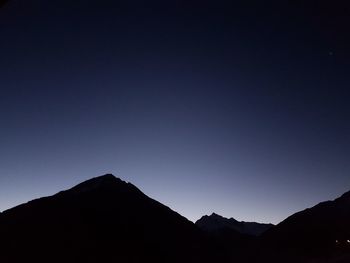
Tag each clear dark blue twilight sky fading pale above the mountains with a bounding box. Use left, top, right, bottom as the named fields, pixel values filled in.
left=0, top=0, right=350, bottom=223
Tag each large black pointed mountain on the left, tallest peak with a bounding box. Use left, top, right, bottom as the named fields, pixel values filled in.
left=0, top=175, right=222, bottom=263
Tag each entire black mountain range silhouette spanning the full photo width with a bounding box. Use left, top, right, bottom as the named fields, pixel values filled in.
left=0, top=174, right=350, bottom=263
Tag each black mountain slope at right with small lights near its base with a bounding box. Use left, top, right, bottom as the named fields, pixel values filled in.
left=262, top=192, right=350, bottom=262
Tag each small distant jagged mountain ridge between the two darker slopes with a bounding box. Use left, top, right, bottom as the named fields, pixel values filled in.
left=195, top=213, right=273, bottom=236
